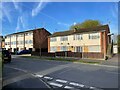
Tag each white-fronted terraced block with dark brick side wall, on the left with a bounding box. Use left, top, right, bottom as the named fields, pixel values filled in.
left=5, top=28, right=50, bottom=52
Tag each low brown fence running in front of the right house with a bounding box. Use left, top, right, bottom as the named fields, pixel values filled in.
left=32, top=51, right=104, bottom=59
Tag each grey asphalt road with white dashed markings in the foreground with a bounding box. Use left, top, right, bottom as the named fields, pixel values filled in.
left=3, top=57, right=120, bottom=90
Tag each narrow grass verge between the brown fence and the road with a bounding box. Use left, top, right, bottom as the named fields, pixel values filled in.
left=21, top=56, right=100, bottom=64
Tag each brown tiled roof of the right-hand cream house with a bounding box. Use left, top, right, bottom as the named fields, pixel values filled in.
left=49, top=25, right=110, bottom=37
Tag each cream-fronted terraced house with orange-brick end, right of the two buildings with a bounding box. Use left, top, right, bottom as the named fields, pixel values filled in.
left=48, top=25, right=111, bottom=58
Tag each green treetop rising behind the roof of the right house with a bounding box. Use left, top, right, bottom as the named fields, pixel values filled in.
left=70, top=20, right=101, bottom=29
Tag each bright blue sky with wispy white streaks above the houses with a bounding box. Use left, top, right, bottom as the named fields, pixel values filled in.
left=0, top=0, right=118, bottom=36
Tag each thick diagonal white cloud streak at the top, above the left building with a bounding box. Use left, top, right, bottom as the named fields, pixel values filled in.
left=32, top=0, right=47, bottom=17
